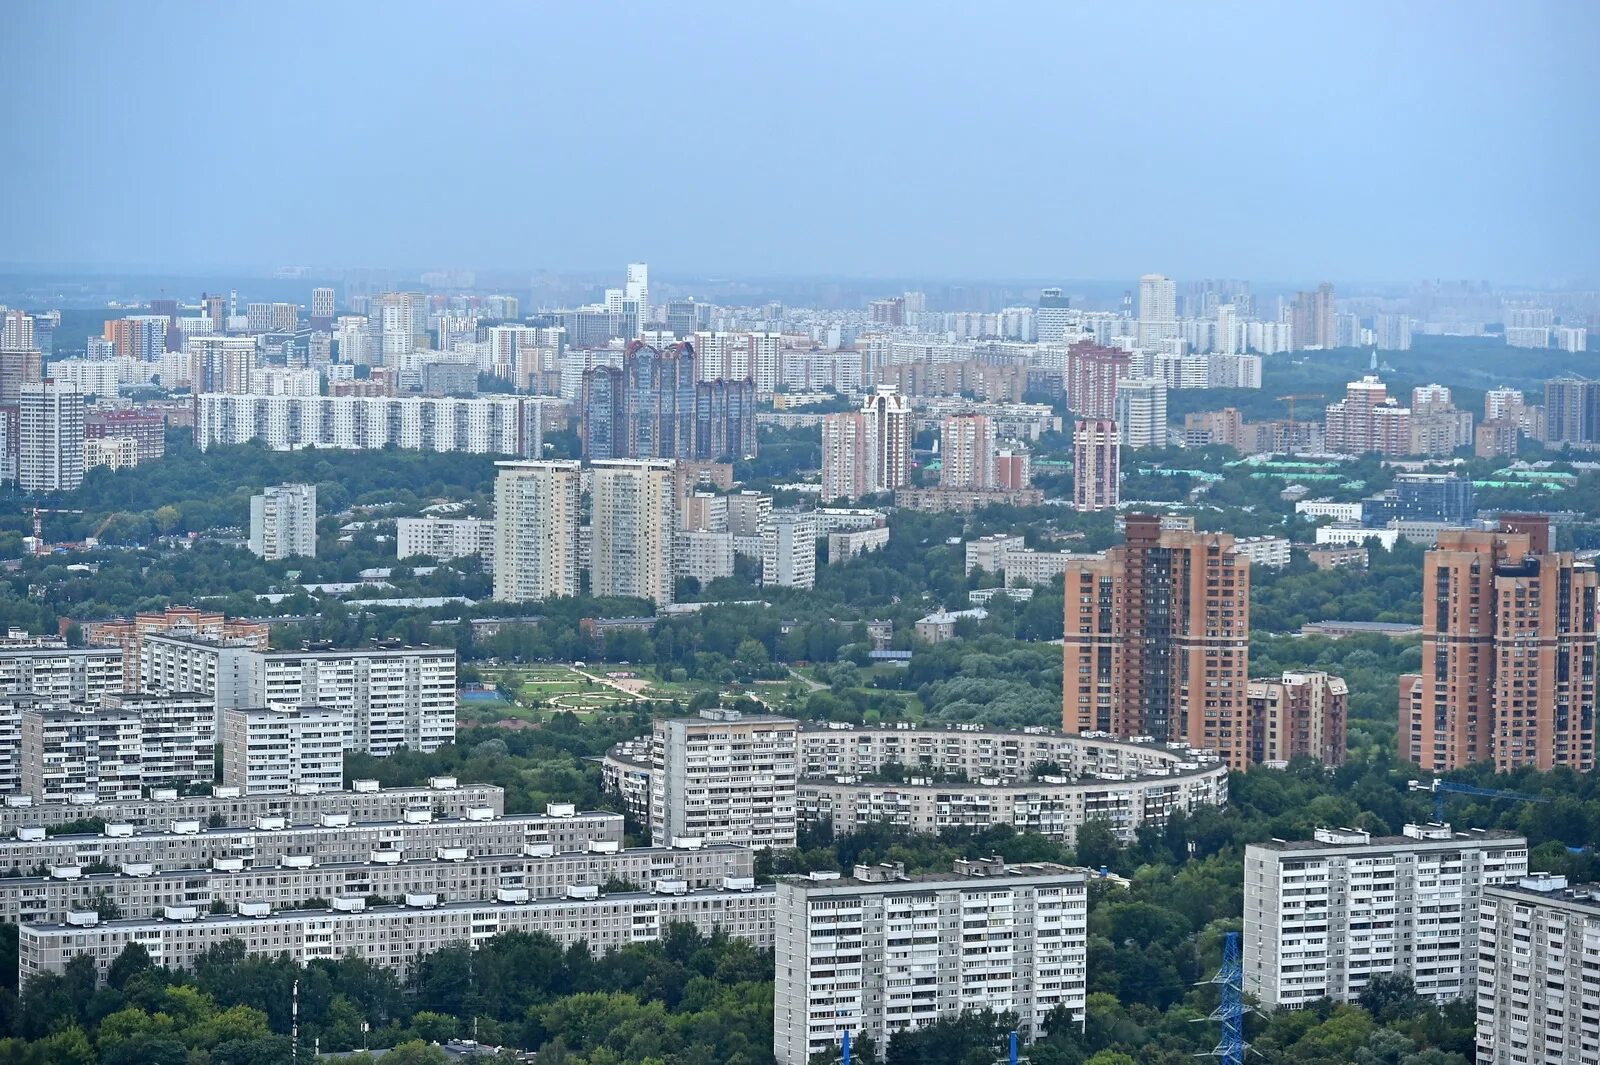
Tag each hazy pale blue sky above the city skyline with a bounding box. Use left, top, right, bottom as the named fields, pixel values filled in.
left=0, top=0, right=1600, bottom=283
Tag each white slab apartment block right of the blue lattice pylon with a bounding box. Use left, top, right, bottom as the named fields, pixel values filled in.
left=1243, top=825, right=1528, bottom=1009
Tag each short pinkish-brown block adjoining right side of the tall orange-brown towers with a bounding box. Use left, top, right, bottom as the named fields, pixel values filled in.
left=1245, top=670, right=1350, bottom=766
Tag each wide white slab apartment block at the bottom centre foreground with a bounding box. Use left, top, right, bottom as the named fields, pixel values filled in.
left=773, top=859, right=1088, bottom=1065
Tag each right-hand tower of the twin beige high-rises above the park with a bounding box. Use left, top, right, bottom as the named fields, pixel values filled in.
left=589, top=459, right=678, bottom=606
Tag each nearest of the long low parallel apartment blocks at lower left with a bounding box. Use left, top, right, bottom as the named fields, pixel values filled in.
left=19, top=884, right=776, bottom=982
